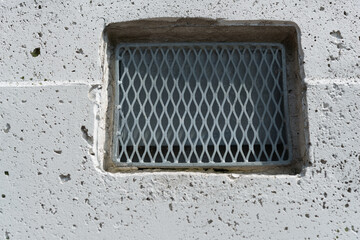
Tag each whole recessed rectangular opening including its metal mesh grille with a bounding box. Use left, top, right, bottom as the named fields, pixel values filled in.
left=102, top=18, right=308, bottom=174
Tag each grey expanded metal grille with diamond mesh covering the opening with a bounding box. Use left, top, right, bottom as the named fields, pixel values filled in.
left=114, top=43, right=291, bottom=167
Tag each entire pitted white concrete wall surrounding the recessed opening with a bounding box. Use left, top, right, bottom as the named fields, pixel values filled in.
left=0, top=0, right=360, bottom=239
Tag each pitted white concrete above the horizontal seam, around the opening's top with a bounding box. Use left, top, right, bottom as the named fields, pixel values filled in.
left=0, top=0, right=360, bottom=82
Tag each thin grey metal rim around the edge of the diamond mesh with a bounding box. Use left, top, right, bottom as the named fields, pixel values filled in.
left=111, top=42, right=293, bottom=168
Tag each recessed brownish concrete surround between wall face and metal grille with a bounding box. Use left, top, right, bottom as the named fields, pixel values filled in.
left=101, top=18, right=311, bottom=172
